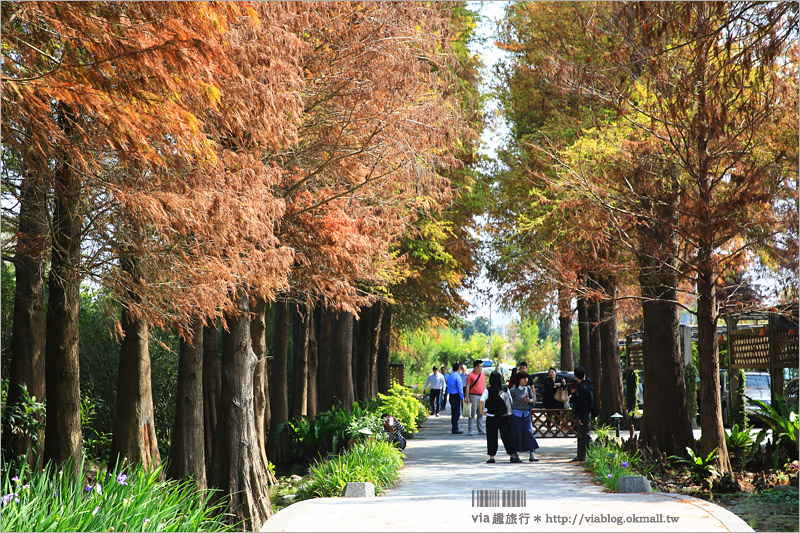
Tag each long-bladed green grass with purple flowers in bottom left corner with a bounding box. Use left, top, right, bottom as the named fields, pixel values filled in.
left=0, top=460, right=235, bottom=531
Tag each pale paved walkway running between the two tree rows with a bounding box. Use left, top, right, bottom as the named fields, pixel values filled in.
left=262, top=406, right=752, bottom=532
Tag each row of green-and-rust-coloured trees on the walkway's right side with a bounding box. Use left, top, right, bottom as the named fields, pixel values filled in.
left=489, top=2, right=798, bottom=472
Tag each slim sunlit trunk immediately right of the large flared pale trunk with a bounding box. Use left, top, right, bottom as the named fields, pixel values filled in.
left=250, top=298, right=270, bottom=472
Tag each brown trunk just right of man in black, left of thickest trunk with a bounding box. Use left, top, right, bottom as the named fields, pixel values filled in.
left=600, top=276, right=628, bottom=423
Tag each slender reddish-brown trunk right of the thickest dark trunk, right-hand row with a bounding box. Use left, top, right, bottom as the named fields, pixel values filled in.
left=692, top=258, right=731, bottom=474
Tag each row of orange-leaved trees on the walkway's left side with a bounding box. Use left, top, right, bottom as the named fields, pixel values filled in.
left=2, top=2, right=481, bottom=528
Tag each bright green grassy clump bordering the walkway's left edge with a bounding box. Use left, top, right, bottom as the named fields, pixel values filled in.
left=298, top=439, right=403, bottom=499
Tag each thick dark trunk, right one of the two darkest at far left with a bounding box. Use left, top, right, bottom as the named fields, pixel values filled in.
left=44, top=104, right=82, bottom=470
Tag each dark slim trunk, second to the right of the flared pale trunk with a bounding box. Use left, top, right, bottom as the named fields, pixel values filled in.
left=269, top=302, right=290, bottom=463
